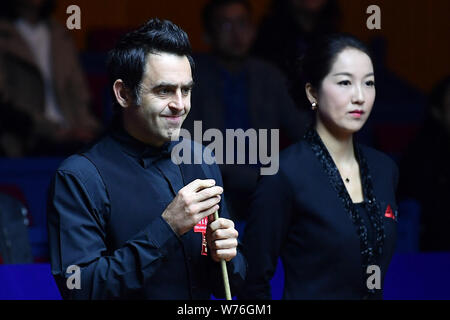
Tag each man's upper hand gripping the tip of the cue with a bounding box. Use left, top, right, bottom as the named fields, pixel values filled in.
left=162, top=179, right=223, bottom=236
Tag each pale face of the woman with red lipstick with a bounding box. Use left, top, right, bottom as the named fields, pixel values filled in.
left=316, top=48, right=375, bottom=134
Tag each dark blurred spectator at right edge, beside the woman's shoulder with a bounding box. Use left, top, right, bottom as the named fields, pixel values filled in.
left=399, top=77, right=450, bottom=251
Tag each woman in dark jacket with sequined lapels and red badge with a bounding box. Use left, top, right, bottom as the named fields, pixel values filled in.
left=241, top=34, right=398, bottom=299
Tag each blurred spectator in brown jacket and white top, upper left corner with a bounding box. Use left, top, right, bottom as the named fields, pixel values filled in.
left=0, top=0, right=99, bottom=156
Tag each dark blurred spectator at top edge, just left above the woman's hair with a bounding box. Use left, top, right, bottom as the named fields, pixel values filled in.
left=253, top=0, right=340, bottom=75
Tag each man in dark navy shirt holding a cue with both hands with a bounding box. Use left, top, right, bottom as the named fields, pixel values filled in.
left=48, top=19, right=246, bottom=299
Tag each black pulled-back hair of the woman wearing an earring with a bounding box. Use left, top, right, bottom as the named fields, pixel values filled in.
left=291, top=33, right=372, bottom=106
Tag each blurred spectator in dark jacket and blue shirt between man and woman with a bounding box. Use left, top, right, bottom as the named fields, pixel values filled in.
left=184, top=0, right=306, bottom=220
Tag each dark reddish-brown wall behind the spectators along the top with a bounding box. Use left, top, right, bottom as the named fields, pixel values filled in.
left=51, top=0, right=450, bottom=93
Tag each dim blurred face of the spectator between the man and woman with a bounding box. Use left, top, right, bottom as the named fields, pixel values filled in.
left=208, top=3, right=255, bottom=59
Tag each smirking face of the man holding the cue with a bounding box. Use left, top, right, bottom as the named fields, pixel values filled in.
left=125, top=53, right=193, bottom=146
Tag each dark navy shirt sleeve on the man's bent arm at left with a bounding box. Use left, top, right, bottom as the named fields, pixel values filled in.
left=47, top=156, right=178, bottom=299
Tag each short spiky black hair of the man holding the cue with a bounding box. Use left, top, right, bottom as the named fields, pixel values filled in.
left=107, top=18, right=194, bottom=110
